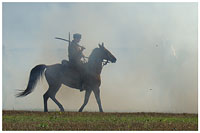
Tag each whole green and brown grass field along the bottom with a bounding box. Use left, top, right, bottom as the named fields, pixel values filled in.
left=2, top=111, right=198, bottom=131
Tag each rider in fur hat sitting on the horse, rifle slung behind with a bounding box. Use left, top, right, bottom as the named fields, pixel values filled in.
left=68, top=33, right=85, bottom=91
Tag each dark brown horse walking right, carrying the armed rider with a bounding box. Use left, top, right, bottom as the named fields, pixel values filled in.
left=16, top=43, right=117, bottom=112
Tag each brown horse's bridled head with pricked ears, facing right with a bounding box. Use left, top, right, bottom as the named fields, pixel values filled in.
left=99, top=43, right=117, bottom=63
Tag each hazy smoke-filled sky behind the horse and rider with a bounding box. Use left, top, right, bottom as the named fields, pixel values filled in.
left=2, top=2, right=198, bottom=113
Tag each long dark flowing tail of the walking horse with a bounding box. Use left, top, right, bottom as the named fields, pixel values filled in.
left=17, top=64, right=47, bottom=97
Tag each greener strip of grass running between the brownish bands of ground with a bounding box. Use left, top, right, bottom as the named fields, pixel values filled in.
left=3, top=114, right=198, bottom=124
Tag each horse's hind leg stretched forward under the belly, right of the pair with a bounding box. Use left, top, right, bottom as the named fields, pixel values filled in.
left=49, top=84, right=64, bottom=112
